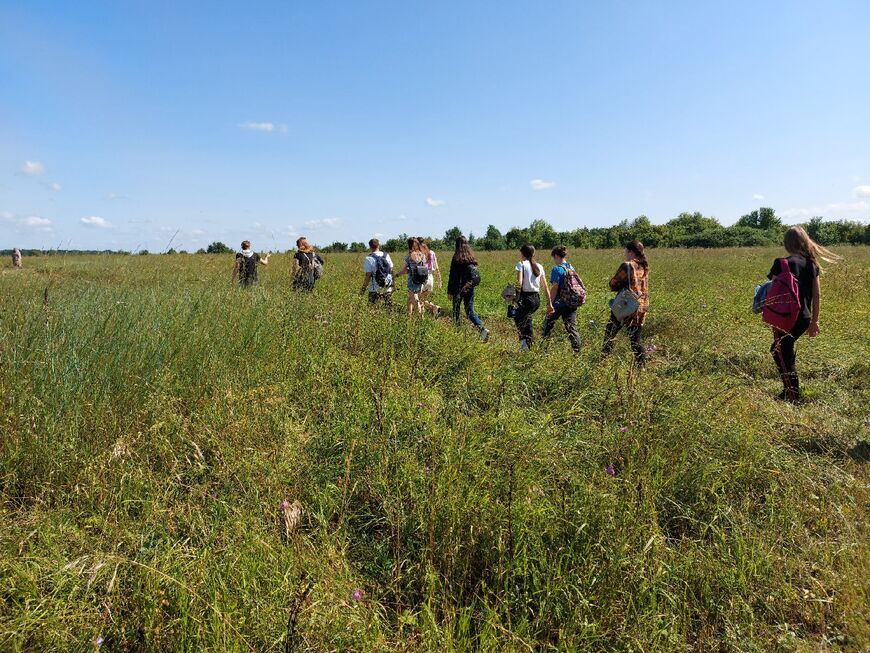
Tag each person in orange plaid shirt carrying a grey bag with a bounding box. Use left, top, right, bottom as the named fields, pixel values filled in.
left=602, top=240, right=649, bottom=365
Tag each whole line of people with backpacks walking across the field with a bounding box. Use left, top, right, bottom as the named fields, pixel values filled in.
left=233, top=226, right=839, bottom=402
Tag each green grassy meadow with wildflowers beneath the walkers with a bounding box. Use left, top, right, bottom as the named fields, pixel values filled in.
left=0, top=248, right=870, bottom=652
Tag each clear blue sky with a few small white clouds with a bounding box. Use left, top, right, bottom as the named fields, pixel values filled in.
left=0, top=0, right=870, bottom=251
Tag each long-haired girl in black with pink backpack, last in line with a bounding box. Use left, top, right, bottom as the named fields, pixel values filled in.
left=767, top=226, right=840, bottom=403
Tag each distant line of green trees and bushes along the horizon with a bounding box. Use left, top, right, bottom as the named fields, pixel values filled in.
left=322, top=208, right=870, bottom=253
